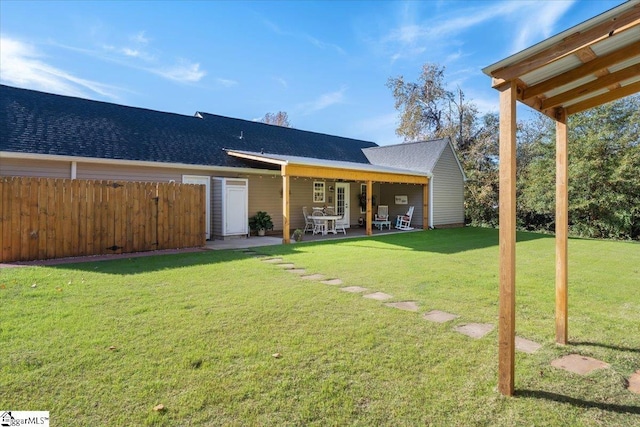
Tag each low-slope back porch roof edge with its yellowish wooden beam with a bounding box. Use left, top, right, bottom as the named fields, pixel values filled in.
left=227, top=150, right=430, bottom=185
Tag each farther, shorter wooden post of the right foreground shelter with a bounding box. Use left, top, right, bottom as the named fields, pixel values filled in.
left=556, top=109, right=569, bottom=344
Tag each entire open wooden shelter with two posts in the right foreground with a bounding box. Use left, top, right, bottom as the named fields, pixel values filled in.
left=483, top=0, right=640, bottom=396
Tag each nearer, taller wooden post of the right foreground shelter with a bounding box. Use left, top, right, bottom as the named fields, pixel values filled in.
left=498, top=81, right=517, bottom=396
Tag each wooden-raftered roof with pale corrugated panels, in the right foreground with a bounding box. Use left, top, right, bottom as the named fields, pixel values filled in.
left=483, top=0, right=640, bottom=119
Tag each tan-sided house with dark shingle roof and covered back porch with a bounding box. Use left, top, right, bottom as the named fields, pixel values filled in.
left=0, top=85, right=464, bottom=242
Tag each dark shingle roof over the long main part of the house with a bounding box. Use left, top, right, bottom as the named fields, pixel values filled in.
left=0, top=85, right=377, bottom=166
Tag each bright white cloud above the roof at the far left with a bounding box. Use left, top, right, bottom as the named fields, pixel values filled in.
left=0, top=35, right=118, bottom=100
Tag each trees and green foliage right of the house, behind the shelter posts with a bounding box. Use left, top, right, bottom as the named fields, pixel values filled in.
left=387, top=60, right=640, bottom=240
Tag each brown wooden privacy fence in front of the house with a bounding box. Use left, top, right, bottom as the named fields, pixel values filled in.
left=0, top=177, right=205, bottom=262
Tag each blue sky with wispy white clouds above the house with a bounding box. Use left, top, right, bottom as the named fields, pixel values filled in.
left=0, top=0, right=623, bottom=145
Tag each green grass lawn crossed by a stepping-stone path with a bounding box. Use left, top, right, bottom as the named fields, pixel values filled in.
left=0, top=228, right=640, bottom=426
